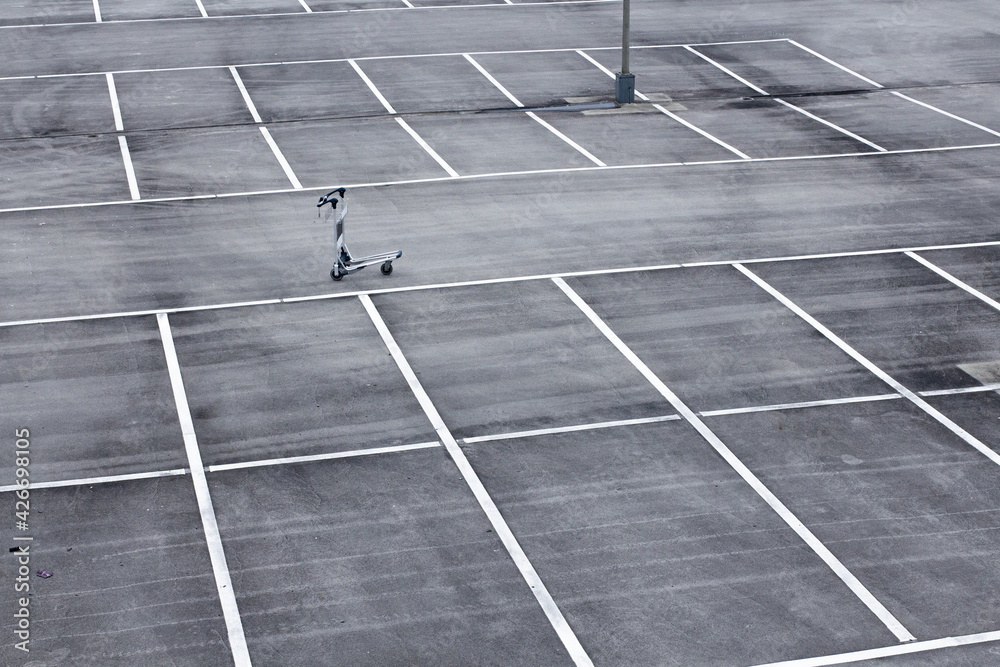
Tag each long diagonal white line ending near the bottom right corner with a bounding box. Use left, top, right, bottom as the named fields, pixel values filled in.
left=553, top=278, right=915, bottom=642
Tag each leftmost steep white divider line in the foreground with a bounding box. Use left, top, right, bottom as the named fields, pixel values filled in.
left=156, top=313, right=251, bottom=667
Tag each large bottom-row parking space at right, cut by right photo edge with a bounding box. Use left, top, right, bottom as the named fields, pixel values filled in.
left=709, top=401, right=1000, bottom=637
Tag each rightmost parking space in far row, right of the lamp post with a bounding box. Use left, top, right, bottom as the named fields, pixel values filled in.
left=696, top=40, right=876, bottom=95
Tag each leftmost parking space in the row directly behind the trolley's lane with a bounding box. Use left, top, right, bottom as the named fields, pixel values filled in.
left=0, top=136, right=129, bottom=208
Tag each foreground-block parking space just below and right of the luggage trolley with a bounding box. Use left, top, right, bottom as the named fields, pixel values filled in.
left=373, top=281, right=673, bottom=437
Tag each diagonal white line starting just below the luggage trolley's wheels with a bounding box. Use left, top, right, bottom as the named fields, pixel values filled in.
left=358, top=294, right=593, bottom=667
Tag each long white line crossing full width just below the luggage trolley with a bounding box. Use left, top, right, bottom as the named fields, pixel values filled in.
left=13, top=241, right=1000, bottom=328
